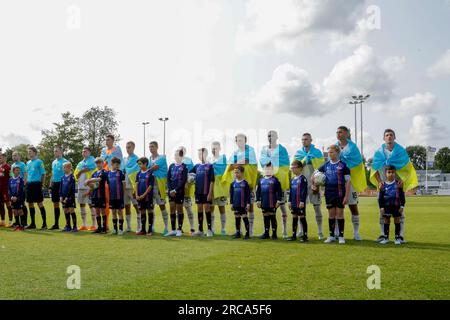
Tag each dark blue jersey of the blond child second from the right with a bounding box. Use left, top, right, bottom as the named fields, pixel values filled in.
left=319, top=160, right=350, bottom=198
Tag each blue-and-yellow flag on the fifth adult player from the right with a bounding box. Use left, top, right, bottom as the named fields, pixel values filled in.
left=225, top=145, right=258, bottom=190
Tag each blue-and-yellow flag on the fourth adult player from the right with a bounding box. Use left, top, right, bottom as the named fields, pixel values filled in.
left=259, top=144, right=290, bottom=190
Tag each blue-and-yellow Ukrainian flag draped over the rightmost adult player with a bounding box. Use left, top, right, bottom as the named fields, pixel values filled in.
left=370, top=143, right=419, bottom=191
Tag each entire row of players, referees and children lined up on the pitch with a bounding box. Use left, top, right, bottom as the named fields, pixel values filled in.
left=0, top=127, right=409, bottom=243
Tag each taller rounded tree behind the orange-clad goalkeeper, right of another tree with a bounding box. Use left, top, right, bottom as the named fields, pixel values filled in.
left=80, top=106, right=120, bottom=156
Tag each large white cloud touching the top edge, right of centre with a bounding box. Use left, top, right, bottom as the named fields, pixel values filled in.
left=236, top=0, right=365, bottom=52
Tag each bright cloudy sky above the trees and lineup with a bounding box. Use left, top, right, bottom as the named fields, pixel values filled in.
left=0, top=0, right=450, bottom=157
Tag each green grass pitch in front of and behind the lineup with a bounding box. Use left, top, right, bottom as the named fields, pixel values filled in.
left=0, top=197, right=450, bottom=299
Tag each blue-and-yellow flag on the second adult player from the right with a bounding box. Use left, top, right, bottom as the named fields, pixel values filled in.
left=336, top=139, right=367, bottom=192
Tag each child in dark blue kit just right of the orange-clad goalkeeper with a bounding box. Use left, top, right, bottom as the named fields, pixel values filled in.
left=107, top=157, right=126, bottom=236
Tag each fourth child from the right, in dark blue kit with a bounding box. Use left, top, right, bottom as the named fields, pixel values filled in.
left=256, top=162, right=283, bottom=240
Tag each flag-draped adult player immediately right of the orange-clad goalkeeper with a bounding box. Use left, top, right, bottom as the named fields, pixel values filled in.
left=122, top=141, right=140, bottom=232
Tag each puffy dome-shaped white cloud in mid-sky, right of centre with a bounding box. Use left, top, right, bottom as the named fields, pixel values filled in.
left=249, top=64, right=325, bottom=116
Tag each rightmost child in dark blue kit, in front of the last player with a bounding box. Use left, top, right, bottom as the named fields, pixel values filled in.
left=378, top=166, right=405, bottom=245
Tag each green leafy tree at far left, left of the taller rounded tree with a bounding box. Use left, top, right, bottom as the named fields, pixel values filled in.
left=37, top=112, right=83, bottom=185
